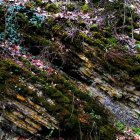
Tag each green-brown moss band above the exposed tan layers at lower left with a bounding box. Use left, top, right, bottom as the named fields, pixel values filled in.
left=0, top=55, right=118, bottom=138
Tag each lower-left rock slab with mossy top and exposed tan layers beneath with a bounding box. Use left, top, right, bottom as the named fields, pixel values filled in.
left=0, top=52, right=117, bottom=139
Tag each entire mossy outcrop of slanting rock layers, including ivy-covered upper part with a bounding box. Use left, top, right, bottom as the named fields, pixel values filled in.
left=0, top=1, right=140, bottom=140
